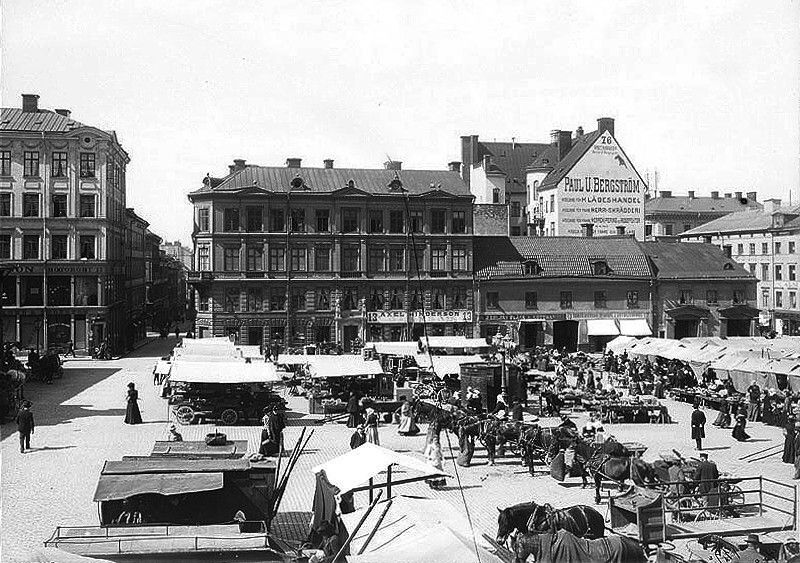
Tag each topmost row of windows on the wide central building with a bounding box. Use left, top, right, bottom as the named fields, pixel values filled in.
left=202, top=206, right=467, bottom=234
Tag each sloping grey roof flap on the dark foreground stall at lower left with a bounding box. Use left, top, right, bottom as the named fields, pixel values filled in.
left=94, top=473, right=223, bottom=502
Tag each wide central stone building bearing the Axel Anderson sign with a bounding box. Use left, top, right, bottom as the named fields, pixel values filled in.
left=189, top=158, right=473, bottom=349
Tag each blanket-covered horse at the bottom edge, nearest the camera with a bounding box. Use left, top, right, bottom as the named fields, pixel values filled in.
left=514, top=530, right=647, bottom=563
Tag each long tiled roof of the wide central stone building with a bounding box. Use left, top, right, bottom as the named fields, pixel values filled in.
left=192, top=165, right=472, bottom=197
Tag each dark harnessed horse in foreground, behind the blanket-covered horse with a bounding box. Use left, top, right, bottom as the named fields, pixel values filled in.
left=497, top=502, right=606, bottom=544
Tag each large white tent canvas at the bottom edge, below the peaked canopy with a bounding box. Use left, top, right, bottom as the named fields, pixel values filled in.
left=341, top=496, right=503, bottom=563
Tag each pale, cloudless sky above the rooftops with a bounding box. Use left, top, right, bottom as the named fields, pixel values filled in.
left=0, top=0, right=800, bottom=244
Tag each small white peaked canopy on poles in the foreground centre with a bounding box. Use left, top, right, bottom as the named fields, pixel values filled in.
left=311, top=442, right=444, bottom=493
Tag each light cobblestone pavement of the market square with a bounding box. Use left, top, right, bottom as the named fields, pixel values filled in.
left=0, top=339, right=794, bottom=561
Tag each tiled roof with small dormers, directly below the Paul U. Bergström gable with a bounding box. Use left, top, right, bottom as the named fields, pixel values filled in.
left=473, top=236, right=652, bottom=279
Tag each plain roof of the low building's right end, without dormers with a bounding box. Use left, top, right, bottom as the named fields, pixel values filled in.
left=639, top=242, right=755, bottom=279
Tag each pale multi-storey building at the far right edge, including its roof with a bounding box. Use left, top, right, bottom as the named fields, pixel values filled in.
left=680, top=199, right=800, bottom=335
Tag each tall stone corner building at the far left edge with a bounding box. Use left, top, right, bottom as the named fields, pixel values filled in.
left=0, top=94, right=130, bottom=352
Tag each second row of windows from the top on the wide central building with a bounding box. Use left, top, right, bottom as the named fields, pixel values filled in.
left=197, top=245, right=470, bottom=273
